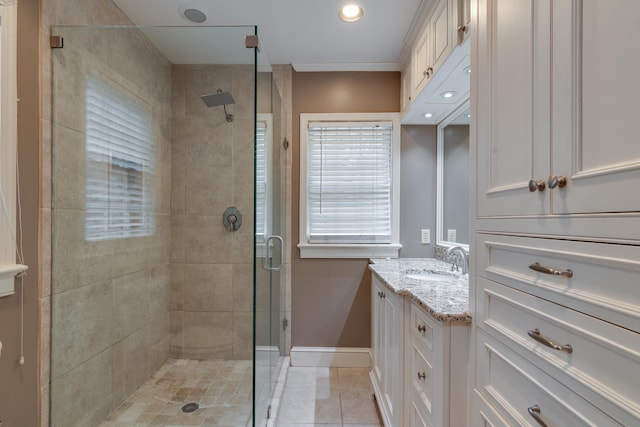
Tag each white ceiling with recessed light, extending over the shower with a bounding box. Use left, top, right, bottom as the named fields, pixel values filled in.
left=113, top=0, right=432, bottom=71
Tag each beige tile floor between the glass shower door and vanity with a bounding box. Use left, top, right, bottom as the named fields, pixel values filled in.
left=278, top=367, right=382, bottom=427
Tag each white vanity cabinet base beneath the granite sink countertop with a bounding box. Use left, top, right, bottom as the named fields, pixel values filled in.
left=370, top=274, right=469, bottom=427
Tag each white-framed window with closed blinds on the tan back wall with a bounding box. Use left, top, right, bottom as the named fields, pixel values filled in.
left=298, top=113, right=401, bottom=258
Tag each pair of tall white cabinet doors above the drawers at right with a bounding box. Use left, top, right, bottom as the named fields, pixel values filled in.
left=472, top=0, right=640, bottom=217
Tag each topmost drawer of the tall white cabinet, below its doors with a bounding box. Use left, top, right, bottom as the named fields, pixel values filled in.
left=476, top=233, right=640, bottom=331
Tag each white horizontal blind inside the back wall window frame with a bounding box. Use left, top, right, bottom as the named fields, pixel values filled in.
left=306, top=122, right=393, bottom=244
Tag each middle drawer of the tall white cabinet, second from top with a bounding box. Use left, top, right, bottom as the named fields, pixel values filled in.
left=476, top=278, right=640, bottom=425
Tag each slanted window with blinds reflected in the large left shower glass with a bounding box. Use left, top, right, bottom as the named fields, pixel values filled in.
left=85, top=78, right=155, bottom=241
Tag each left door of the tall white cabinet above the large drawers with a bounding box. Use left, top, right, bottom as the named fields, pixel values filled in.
left=471, top=0, right=551, bottom=217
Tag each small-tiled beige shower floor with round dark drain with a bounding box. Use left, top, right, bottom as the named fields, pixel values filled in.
left=100, top=359, right=252, bottom=427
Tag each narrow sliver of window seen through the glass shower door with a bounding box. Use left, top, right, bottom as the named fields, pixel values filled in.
left=256, top=114, right=272, bottom=243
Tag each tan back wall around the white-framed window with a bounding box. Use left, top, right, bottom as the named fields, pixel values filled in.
left=291, top=72, right=400, bottom=347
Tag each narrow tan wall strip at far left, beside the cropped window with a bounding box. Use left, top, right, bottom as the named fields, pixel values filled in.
left=0, top=0, right=40, bottom=427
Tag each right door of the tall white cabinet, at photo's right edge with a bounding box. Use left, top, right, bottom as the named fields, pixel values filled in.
left=550, top=0, right=640, bottom=213
